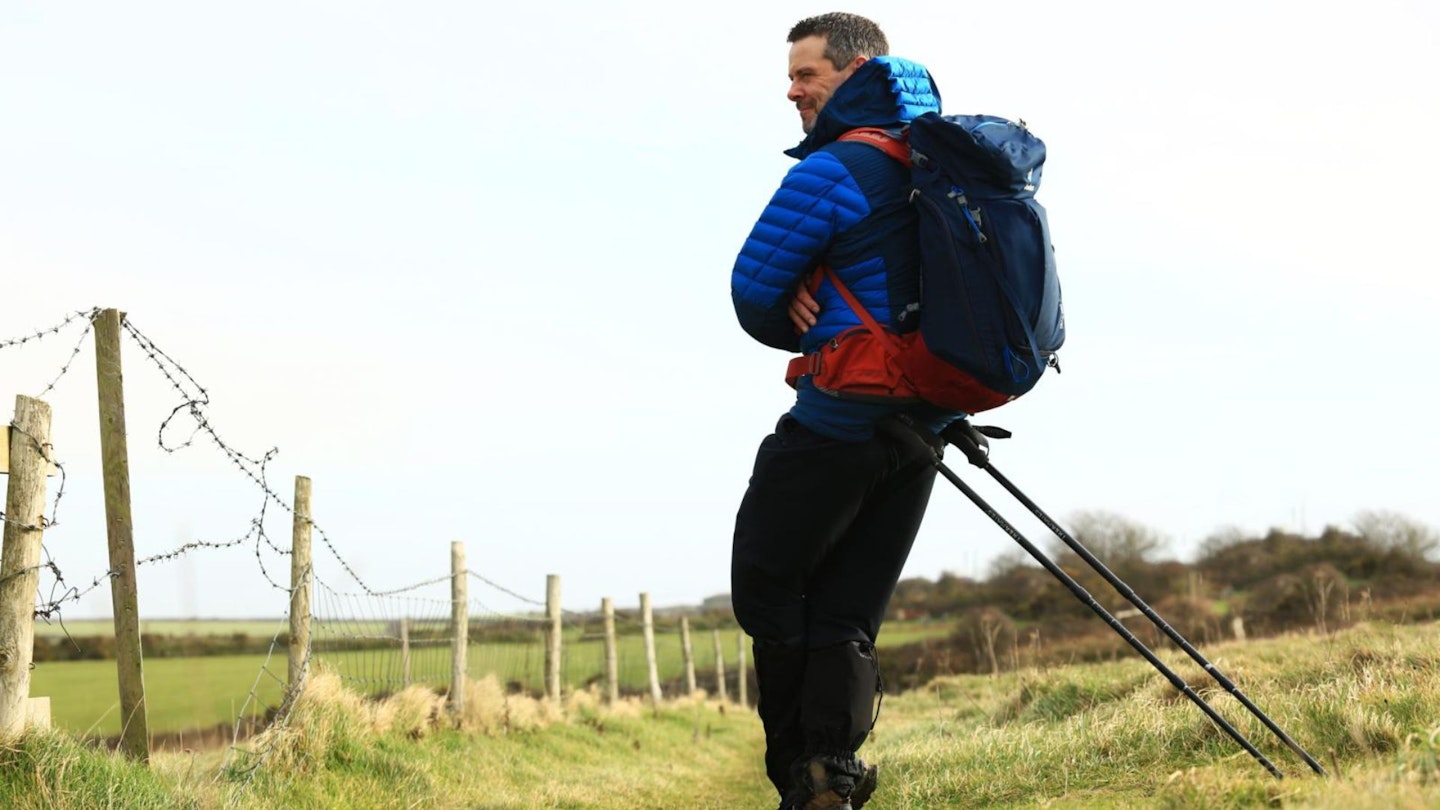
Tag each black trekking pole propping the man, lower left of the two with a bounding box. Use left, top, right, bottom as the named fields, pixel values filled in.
left=878, top=417, right=1284, bottom=778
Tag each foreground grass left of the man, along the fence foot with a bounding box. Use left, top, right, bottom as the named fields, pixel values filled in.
left=0, top=676, right=770, bottom=810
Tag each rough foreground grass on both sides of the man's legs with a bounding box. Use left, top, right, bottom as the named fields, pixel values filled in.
left=8, top=624, right=1440, bottom=810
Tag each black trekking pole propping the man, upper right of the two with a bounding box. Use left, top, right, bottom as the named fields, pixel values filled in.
left=940, top=422, right=1326, bottom=777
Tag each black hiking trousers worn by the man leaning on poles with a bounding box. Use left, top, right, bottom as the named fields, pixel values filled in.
left=730, top=415, right=935, bottom=794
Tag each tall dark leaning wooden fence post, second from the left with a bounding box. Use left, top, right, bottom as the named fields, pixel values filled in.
left=95, top=310, right=150, bottom=762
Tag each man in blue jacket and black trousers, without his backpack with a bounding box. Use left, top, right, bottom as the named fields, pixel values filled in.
left=732, top=13, right=958, bottom=810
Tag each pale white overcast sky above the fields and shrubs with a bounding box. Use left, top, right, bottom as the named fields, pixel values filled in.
left=0, top=0, right=1440, bottom=617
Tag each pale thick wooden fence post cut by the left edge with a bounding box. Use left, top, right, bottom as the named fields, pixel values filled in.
left=0, top=396, right=50, bottom=738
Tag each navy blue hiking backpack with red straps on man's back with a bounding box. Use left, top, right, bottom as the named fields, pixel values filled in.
left=834, top=112, right=1066, bottom=414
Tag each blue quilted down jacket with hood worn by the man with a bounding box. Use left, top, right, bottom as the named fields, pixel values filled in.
left=730, top=56, right=948, bottom=441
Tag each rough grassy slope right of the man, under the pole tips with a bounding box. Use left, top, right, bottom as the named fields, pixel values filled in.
left=867, top=624, right=1440, bottom=810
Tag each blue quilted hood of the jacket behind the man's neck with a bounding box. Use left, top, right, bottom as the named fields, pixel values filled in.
left=785, top=56, right=940, bottom=160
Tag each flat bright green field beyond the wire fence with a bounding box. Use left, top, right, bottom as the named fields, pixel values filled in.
left=30, top=621, right=949, bottom=736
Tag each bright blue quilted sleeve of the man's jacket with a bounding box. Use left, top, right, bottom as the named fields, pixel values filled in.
left=730, top=151, right=870, bottom=352
